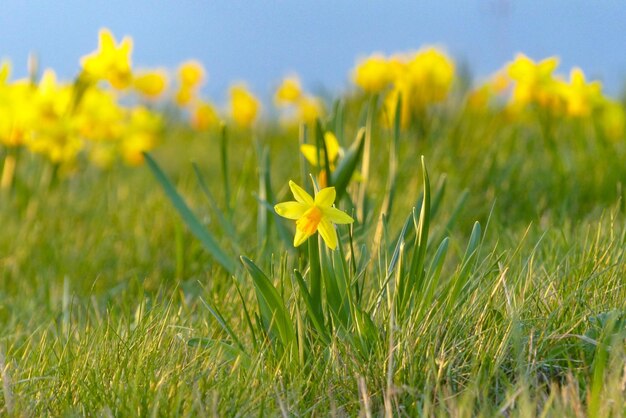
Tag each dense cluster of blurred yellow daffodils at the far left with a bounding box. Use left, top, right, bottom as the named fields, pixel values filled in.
left=0, top=30, right=166, bottom=171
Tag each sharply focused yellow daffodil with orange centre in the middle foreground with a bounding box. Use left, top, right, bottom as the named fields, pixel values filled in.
left=274, top=180, right=354, bottom=250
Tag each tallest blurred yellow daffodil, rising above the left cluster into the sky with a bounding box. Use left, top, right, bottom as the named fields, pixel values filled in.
left=81, top=29, right=133, bottom=90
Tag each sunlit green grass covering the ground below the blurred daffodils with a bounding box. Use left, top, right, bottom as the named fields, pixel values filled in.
left=0, top=99, right=626, bottom=416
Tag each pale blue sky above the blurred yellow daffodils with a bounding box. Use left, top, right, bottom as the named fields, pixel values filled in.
left=0, top=0, right=626, bottom=98
